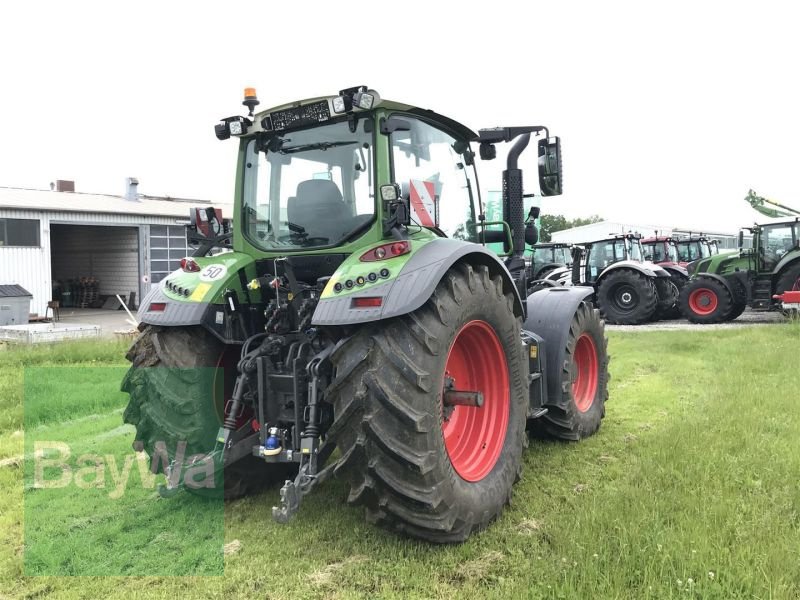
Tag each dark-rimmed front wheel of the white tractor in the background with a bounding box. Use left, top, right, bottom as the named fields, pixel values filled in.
left=597, top=269, right=658, bottom=325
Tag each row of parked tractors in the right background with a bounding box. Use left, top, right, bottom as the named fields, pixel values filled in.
left=531, top=218, right=800, bottom=325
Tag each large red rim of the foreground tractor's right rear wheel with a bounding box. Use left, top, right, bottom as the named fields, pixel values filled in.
left=442, top=321, right=510, bottom=482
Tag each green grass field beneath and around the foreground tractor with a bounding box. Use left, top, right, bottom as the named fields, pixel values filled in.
left=0, top=323, right=800, bottom=599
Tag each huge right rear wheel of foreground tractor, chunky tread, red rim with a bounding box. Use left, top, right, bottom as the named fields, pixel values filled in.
left=328, top=263, right=528, bottom=543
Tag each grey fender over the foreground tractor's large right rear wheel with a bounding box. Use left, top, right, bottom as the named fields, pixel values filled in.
left=312, top=238, right=523, bottom=325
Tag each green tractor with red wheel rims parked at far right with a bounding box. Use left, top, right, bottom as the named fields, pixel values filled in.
left=679, top=216, right=800, bottom=323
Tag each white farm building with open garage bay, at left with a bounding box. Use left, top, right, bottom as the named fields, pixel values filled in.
left=0, top=179, right=231, bottom=315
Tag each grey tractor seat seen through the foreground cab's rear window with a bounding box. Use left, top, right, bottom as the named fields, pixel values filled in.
left=286, top=179, right=354, bottom=246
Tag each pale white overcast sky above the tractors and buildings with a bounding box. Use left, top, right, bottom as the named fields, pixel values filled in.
left=0, top=0, right=800, bottom=231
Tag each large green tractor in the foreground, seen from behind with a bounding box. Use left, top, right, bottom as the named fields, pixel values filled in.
left=122, top=86, right=608, bottom=542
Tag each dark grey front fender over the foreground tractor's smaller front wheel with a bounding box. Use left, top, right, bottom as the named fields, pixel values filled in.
left=522, top=286, right=594, bottom=410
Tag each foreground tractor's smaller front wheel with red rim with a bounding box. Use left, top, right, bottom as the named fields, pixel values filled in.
left=531, top=302, right=609, bottom=440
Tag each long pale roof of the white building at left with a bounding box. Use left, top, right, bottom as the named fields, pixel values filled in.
left=0, top=187, right=233, bottom=218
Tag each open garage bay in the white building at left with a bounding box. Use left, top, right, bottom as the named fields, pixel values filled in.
left=50, top=224, right=139, bottom=298
